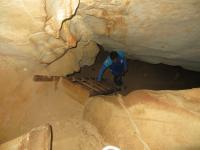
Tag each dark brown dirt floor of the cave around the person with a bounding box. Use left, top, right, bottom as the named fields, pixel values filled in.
left=74, top=50, right=200, bottom=95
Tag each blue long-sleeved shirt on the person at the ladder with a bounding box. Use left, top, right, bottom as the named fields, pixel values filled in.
left=97, top=51, right=127, bottom=81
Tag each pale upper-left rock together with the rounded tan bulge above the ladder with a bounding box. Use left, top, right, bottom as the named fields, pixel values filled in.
left=0, top=0, right=98, bottom=75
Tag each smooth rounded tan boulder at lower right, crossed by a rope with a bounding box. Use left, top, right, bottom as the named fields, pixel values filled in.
left=84, top=89, right=200, bottom=150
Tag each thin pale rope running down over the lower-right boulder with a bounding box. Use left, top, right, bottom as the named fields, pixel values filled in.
left=117, top=95, right=150, bottom=150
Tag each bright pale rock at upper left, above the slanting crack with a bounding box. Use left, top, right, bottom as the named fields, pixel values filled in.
left=0, top=0, right=79, bottom=64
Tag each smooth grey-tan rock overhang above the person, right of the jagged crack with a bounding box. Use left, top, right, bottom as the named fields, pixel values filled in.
left=72, top=0, right=200, bottom=70
